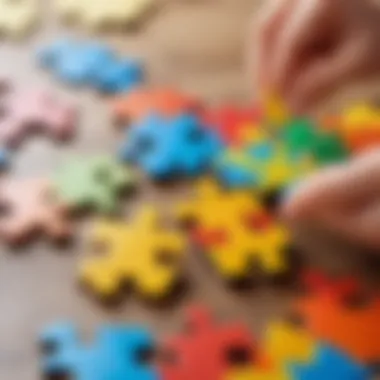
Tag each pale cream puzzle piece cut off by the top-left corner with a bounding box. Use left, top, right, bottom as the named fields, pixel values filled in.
left=0, top=0, right=40, bottom=37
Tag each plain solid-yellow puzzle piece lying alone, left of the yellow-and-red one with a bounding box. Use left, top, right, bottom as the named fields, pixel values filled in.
left=80, top=208, right=184, bottom=298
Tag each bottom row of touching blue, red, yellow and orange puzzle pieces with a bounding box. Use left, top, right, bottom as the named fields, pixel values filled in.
left=40, top=273, right=380, bottom=380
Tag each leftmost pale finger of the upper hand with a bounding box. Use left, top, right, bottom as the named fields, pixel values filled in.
left=252, top=0, right=297, bottom=88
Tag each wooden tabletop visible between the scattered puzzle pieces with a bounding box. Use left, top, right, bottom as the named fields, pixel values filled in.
left=0, top=0, right=378, bottom=380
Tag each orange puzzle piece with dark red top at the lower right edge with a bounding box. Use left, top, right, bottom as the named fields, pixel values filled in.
left=294, top=272, right=380, bottom=363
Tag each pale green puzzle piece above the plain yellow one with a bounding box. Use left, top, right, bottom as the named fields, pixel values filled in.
left=54, top=156, right=134, bottom=213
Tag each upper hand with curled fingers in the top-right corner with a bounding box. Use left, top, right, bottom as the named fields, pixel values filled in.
left=253, top=0, right=380, bottom=113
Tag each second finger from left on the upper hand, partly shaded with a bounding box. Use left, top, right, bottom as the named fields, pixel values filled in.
left=267, top=0, right=332, bottom=94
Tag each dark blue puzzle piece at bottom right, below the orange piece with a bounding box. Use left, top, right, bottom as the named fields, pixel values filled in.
left=289, top=345, right=371, bottom=380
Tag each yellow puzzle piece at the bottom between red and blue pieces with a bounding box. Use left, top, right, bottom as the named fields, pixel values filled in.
left=226, top=322, right=316, bottom=380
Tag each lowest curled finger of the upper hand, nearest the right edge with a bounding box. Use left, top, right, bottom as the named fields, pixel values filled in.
left=285, top=37, right=366, bottom=114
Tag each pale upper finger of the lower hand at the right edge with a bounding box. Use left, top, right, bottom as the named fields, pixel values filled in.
left=283, top=149, right=380, bottom=223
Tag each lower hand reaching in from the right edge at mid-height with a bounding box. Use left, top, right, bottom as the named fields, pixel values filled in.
left=283, top=149, right=380, bottom=248
